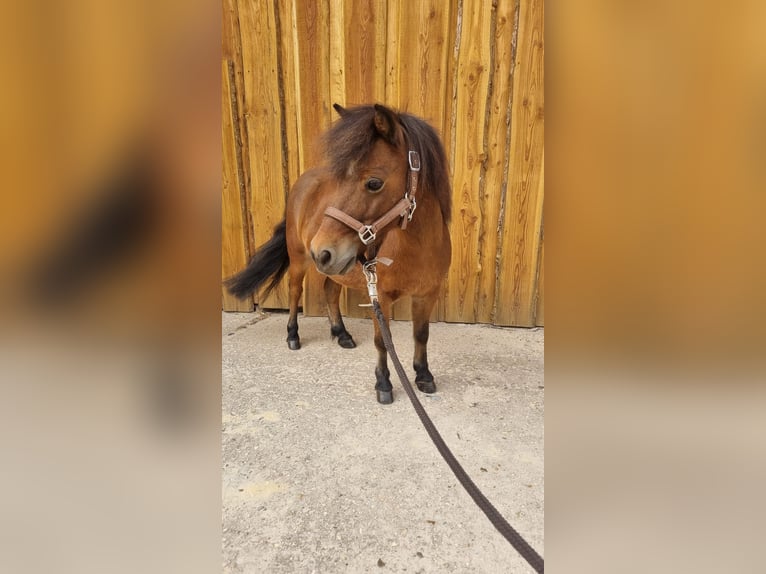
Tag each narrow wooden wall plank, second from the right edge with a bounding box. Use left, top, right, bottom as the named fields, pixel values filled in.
left=475, top=0, right=519, bottom=323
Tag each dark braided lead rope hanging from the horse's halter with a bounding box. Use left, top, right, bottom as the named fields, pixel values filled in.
left=371, top=304, right=545, bottom=573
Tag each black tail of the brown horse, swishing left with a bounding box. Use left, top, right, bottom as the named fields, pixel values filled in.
left=224, top=219, right=290, bottom=299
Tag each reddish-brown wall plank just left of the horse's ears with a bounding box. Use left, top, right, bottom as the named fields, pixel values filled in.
left=294, top=0, right=335, bottom=316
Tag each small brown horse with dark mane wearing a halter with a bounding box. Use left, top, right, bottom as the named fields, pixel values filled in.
left=226, top=104, right=452, bottom=404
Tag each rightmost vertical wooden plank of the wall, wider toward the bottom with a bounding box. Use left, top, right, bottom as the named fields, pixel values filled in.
left=495, top=0, right=544, bottom=326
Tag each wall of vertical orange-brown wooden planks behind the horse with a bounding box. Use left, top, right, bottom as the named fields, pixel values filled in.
left=222, top=0, right=544, bottom=327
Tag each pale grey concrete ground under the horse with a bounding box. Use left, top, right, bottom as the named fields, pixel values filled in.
left=222, top=313, right=544, bottom=574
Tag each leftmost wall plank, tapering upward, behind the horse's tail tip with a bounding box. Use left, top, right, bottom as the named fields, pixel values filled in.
left=221, top=59, right=253, bottom=311
